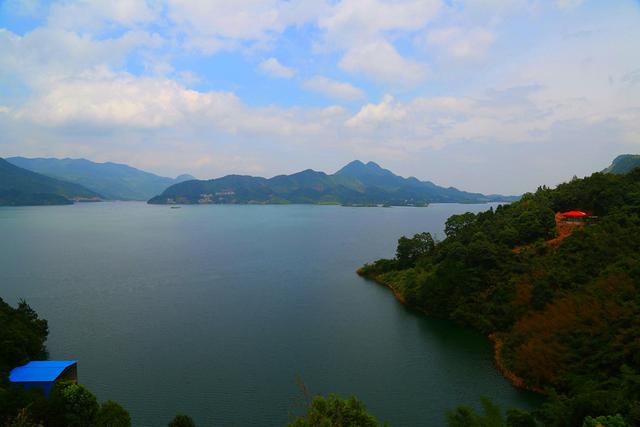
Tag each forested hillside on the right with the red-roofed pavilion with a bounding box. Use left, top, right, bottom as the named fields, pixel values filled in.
left=359, top=169, right=640, bottom=426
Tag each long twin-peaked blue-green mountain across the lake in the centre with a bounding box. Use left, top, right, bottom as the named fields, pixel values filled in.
left=149, top=160, right=517, bottom=206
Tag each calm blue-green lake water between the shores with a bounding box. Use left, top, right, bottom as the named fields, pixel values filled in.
left=0, top=203, right=537, bottom=427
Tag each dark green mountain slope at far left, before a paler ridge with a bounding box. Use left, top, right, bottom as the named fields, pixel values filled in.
left=0, top=158, right=101, bottom=206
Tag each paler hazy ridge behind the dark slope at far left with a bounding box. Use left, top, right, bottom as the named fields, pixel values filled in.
left=7, top=157, right=195, bottom=200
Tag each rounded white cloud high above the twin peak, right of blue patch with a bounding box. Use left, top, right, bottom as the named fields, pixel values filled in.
left=338, top=40, right=427, bottom=86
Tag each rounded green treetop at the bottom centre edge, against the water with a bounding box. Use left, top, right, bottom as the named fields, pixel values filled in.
left=289, top=394, right=380, bottom=427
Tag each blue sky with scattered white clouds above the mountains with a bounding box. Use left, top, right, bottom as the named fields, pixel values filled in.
left=0, top=0, right=640, bottom=194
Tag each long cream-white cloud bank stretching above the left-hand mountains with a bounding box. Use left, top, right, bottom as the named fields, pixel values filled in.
left=14, top=69, right=344, bottom=137
